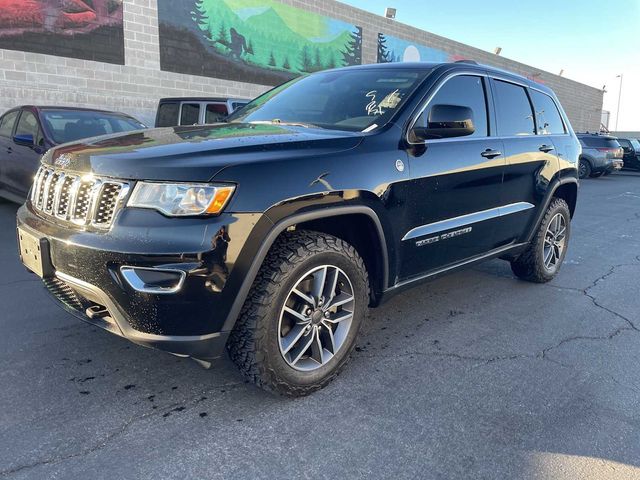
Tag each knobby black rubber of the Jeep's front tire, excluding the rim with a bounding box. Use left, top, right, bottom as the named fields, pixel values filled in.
left=227, top=230, right=369, bottom=397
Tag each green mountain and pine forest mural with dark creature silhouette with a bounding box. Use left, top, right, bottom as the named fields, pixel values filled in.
left=158, top=0, right=362, bottom=85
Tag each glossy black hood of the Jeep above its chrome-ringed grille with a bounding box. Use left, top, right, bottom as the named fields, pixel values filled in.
left=42, top=123, right=363, bottom=182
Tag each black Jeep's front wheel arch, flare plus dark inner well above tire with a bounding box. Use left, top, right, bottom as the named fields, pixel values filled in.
left=222, top=206, right=389, bottom=332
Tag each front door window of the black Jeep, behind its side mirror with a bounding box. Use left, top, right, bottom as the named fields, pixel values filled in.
left=416, top=75, right=489, bottom=137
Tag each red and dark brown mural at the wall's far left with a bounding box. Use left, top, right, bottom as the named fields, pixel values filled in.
left=0, top=0, right=124, bottom=64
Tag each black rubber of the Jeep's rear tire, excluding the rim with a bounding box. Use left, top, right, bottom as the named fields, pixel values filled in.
left=511, top=198, right=571, bottom=283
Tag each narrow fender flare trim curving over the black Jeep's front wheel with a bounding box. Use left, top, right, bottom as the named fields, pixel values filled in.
left=222, top=206, right=389, bottom=332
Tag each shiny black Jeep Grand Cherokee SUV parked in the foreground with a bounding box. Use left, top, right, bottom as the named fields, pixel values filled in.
left=17, top=62, right=580, bottom=395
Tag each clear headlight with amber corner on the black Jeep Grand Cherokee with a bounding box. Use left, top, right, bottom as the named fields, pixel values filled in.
left=127, top=182, right=235, bottom=216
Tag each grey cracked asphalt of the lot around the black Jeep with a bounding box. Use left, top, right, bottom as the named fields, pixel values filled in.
left=0, top=172, right=640, bottom=480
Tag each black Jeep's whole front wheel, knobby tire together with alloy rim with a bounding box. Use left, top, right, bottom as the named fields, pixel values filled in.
left=227, top=230, right=369, bottom=397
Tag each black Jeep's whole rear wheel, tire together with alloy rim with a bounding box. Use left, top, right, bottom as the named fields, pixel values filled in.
left=511, top=198, right=571, bottom=283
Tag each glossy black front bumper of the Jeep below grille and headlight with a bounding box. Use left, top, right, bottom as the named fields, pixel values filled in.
left=17, top=204, right=270, bottom=360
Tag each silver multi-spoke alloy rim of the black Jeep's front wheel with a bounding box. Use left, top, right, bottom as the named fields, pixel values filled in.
left=278, top=265, right=355, bottom=371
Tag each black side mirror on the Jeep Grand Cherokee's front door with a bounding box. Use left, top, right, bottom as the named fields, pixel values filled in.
left=412, top=105, right=476, bottom=140
